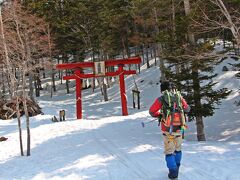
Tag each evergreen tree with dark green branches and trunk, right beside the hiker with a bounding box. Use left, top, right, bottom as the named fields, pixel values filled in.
left=166, top=0, right=230, bottom=141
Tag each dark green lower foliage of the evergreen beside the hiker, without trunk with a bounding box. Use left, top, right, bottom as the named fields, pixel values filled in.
left=168, top=47, right=231, bottom=120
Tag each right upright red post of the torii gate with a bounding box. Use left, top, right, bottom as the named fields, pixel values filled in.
left=118, top=65, right=128, bottom=116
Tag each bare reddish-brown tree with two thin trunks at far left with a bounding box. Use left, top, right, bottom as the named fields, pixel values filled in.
left=0, top=1, right=49, bottom=156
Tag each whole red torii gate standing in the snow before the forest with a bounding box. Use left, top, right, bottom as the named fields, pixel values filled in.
left=56, top=57, right=141, bottom=119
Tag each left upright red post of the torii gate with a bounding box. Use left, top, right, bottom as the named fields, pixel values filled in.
left=75, top=70, right=82, bottom=119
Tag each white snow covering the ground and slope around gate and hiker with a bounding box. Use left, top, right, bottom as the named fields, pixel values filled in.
left=0, top=56, right=240, bottom=180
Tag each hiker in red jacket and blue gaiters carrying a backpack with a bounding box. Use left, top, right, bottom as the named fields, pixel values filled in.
left=149, top=81, right=190, bottom=179
